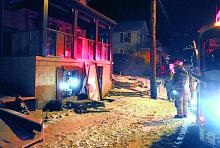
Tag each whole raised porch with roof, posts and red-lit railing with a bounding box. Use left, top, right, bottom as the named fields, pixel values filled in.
left=0, top=0, right=116, bottom=61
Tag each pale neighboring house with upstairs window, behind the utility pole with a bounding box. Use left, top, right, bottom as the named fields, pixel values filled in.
left=113, top=20, right=150, bottom=54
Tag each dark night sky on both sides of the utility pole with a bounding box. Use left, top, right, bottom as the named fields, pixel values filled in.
left=88, top=0, right=219, bottom=51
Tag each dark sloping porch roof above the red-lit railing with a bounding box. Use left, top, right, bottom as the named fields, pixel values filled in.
left=11, top=0, right=117, bottom=26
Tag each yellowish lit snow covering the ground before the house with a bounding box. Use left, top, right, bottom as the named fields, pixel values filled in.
left=37, top=76, right=184, bottom=148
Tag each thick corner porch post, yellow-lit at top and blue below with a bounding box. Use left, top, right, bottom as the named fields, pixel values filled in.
left=39, top=0, right=49, bottom=56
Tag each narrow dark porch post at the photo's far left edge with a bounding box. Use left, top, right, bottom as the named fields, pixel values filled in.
left=0, top=0, right=4, bottom=56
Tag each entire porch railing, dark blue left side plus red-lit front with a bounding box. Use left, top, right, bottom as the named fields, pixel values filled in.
left=12, top=29, right=110, bottom=61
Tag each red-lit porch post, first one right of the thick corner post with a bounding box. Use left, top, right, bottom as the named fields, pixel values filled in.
left=71, top=9, right=78, bottom=59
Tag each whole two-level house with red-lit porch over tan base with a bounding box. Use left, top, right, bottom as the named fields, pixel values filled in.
left=0, top=0, right=116, bottom=107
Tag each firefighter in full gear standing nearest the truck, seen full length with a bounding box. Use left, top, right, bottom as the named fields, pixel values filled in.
left=172, top=61, right=190, bottom=118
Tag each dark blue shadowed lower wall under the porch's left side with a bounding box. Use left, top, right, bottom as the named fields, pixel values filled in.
left=0, top=57, right=35, bottom=96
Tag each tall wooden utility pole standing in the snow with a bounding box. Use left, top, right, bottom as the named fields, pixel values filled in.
left=150, top=0, right=157, bottom=99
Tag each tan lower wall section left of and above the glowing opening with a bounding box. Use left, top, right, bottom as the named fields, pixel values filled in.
left=35, top=57, right=83, bottom=108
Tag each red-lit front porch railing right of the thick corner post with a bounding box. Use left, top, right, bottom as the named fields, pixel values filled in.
left=47, top=29, right=110, bottom=61
